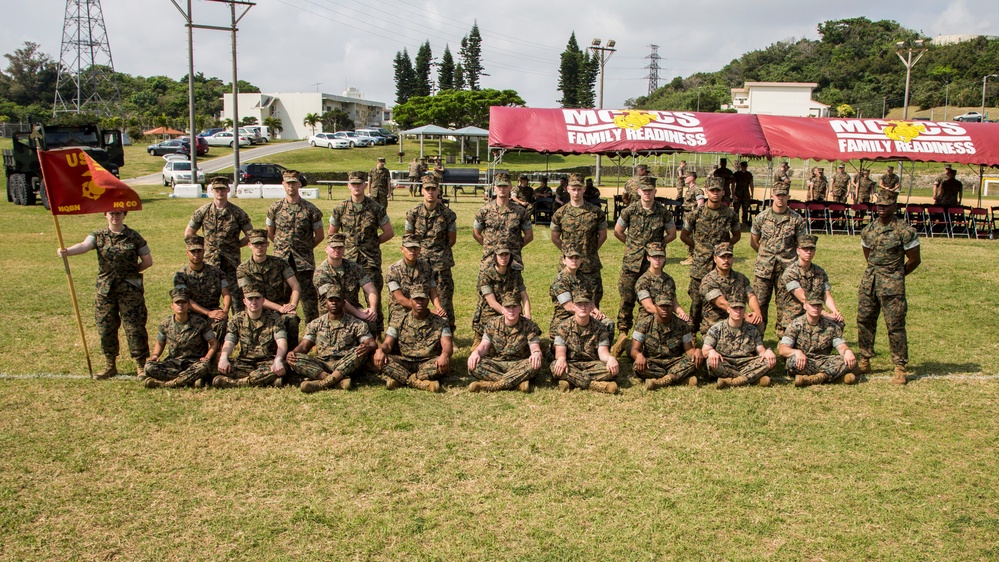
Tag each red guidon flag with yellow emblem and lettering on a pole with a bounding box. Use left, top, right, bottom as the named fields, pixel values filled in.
left=38, top=148, right=142, bottom=215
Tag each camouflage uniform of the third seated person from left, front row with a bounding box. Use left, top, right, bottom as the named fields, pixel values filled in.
left=288, top=308, right=371, bottom=380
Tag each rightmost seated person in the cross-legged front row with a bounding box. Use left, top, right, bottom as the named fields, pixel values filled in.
left=777, top=297, right=857, bottom=387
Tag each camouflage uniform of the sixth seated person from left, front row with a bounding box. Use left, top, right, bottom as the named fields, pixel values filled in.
left=552, top=312, right=615, bottom=388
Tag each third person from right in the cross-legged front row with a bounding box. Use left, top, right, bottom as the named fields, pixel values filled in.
left=631, top=293, right=704, bottom=390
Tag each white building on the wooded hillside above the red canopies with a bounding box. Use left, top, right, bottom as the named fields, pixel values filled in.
left=722, top=82, right=829, bottom=117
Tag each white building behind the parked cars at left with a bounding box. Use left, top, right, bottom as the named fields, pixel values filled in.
left=221, top=88, right=386, bottom=139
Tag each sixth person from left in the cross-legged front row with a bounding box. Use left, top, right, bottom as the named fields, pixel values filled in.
left=551, top=291, right=619, bottom=394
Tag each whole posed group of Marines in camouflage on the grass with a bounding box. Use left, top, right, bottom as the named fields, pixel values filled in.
left=60, top=152, right=919, bottom=393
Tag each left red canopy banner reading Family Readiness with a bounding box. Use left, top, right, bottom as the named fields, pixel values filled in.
left=489, top=107, right=770, bottom=157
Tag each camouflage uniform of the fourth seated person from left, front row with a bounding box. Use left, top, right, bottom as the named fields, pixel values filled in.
left=381, top=313, right=451, bottom=384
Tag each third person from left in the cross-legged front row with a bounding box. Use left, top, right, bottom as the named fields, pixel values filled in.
left=288, top=283, right=377, bottom=393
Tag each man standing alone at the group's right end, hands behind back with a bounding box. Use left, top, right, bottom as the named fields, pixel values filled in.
left=857, top=189, right=921, bottom=384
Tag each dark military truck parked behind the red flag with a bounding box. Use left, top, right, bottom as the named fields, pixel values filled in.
left=3, top=125, right=125, bottom=209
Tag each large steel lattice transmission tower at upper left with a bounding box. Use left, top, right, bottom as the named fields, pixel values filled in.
left=52, top=0, right=121, bottom=117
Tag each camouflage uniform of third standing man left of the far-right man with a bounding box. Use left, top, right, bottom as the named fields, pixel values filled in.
left=617, top=200, right=676, bottom=334
